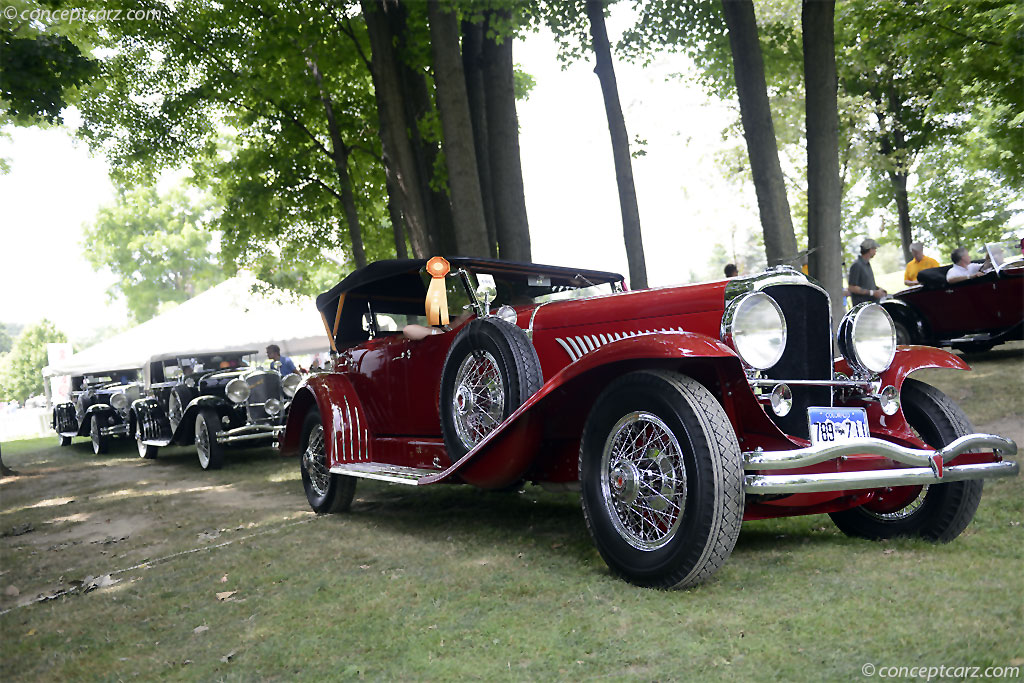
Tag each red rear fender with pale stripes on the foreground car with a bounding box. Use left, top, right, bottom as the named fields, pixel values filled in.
left=281, top=373, right=373, bottom=467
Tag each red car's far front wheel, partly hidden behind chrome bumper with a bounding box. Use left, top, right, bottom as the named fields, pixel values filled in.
left=829, top=379, right=983, bottom=543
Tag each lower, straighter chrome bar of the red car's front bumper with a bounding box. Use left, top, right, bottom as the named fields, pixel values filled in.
left=743, top=460, right=1020, bottom=495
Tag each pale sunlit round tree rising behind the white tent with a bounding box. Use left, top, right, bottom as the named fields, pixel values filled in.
left=83, top=187, right=224, bottom=323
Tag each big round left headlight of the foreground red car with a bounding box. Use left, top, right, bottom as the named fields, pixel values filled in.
left=722, top=292, right=786, bottom=370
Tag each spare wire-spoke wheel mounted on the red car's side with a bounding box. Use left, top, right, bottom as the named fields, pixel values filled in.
left=438, top=317, right=544, bottom=462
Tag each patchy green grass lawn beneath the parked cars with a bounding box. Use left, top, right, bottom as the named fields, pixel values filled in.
left=0, top=343, right=1024, bottom=681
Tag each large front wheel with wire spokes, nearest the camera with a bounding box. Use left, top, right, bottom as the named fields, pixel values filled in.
left=580, top=371, right=744, bottom=589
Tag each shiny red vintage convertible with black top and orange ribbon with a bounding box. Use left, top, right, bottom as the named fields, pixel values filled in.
left=282, top=258, right=1019, bottom=588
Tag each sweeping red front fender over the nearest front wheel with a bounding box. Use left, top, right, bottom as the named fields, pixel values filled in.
left=421, top=332, right=742, bottom=488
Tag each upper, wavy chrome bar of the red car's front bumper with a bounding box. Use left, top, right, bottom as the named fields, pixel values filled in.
left=743, top=434, right=1017, bottom=470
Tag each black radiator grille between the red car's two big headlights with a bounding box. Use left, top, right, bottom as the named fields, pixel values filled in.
left=762, top=284, right=833, bottom=438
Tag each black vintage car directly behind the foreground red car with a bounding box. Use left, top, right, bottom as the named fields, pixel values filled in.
left=130, top=350, right=301, bottom=469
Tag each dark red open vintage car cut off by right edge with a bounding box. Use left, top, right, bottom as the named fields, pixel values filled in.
left=882, top=241, right=1024, bottom=352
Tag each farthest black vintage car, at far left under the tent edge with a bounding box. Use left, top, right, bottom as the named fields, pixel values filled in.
left=51, top=369, right=142, bottom=455
